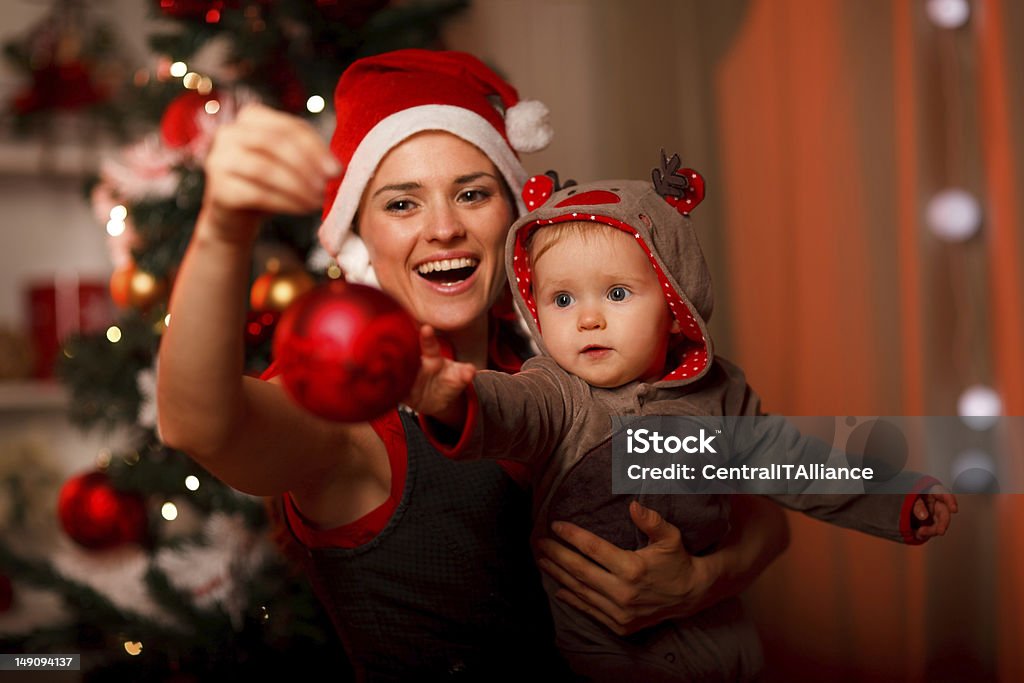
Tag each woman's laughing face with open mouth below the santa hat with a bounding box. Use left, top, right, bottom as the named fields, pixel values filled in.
left=357, top=131, right=513, bottom=332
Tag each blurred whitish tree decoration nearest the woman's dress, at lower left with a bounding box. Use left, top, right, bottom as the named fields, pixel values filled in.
left=155, top=513, right=274, bottom=629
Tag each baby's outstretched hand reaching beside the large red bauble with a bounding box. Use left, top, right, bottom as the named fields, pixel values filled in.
left=406, top=325, right=476, bottom=427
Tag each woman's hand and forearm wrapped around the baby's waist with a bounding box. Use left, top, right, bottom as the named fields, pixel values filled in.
left=538, top=496, right=790, bottom=635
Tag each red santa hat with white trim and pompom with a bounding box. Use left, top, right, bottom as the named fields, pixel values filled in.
left=319, top=49, right=552, bottom=285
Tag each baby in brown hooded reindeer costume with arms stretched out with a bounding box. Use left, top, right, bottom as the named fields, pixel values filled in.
left=410, top=155, right=957, bottom=681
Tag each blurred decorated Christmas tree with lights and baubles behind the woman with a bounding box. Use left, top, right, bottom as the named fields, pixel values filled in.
left=0, top=0, right=466, bottom=681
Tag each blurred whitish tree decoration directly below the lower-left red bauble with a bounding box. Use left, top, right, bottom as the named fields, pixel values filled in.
left=52, top=539, right=180, bottom=626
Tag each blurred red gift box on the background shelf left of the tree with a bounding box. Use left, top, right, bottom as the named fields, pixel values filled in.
left=28, top=275, right=114, bottom=379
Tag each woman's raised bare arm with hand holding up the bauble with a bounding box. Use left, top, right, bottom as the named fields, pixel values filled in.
left=157, top=106, right=382, bottom=505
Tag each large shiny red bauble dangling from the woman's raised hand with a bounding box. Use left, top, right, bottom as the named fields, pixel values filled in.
left=273, top=281, right=420, bottom=422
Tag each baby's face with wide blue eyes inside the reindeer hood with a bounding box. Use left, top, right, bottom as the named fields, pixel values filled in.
left=532, top=226, right=675, bottom=388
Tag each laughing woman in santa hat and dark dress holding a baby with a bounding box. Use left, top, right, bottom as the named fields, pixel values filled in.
left=158, top=50, right=786, bottom=680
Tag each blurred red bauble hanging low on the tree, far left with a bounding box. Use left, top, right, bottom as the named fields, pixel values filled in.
left=57, top=472, right=146, bottom=550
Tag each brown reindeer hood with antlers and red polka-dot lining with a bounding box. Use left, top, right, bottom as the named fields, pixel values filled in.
left=505, top=155, right=714, bottom=386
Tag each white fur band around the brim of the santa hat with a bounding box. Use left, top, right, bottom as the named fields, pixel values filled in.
left=319, top=104, right=526, bottom=284
